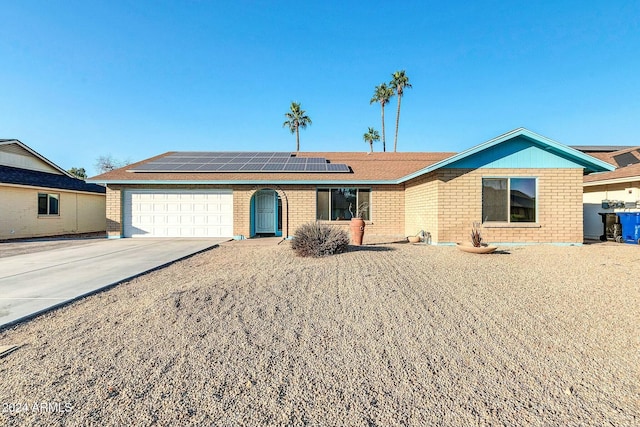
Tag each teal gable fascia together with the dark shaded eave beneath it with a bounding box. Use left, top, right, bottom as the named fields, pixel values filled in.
left=399, top=128, right=615, bottom=182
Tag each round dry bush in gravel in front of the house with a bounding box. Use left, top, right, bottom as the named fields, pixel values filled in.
left=291, top=222, right=349, bottom=257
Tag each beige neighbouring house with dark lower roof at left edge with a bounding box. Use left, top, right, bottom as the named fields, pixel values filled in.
left=0, top=139, right=106, bottom=239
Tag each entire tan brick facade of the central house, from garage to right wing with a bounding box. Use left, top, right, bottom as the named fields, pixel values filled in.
left=106, top=169, right=583, bottom=243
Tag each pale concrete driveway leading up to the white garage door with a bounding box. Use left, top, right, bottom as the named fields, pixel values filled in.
left=0, top=238, right=227, bottom=328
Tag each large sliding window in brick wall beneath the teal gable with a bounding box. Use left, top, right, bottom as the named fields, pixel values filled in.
left=482, top=178, right=537, bottom=222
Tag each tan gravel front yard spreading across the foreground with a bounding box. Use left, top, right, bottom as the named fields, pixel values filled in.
left=0, top=242, right=640, bottom=426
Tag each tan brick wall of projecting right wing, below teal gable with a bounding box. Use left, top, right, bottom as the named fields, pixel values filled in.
left=407, top=169, right=583, bottom=243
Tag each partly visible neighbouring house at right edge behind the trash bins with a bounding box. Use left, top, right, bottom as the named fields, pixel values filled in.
left=579, top=147, right=640, bottom=239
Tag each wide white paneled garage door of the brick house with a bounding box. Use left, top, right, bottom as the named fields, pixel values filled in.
left=124, top=190, right=233, bottom=237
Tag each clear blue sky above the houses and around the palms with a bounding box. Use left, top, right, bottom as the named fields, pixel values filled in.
left=0, top=0, right=640, bottom=175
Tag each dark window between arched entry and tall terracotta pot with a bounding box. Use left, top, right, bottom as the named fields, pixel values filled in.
left=316, top=188, right=371, bottom=221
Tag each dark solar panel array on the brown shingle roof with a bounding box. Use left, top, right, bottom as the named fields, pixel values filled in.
left=129, top=151, right=350, bottom=173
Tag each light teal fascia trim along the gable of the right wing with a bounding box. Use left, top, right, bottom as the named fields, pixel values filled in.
left=399, top=128, right=615, bottom=182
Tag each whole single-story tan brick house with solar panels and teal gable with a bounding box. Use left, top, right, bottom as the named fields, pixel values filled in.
left=89, top=128, right=613, bottom=244
